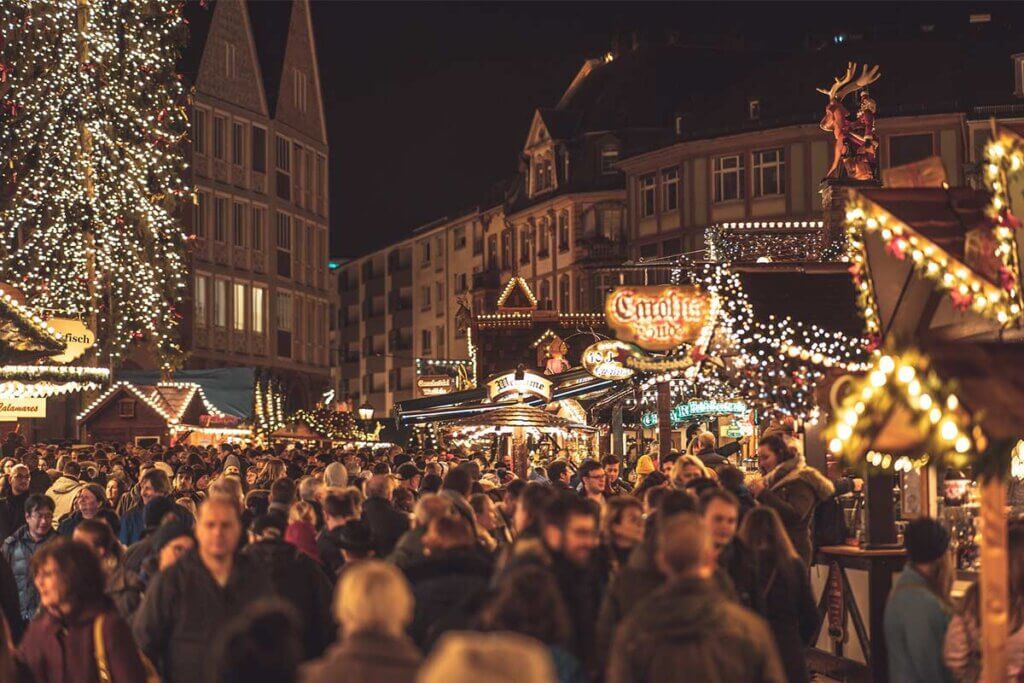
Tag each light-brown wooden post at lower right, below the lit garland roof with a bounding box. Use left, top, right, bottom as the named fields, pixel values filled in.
left=979, top=476, right=1010, bottom=683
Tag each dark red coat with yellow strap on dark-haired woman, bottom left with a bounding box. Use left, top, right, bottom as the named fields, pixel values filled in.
left=17, top=604, right=146, bottom=683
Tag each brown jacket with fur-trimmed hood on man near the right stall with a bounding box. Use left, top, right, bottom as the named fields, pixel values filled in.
left=757, top=456, right=836, bottom=566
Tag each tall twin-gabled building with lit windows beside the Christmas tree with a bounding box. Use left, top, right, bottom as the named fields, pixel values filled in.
left=183, top=0, right=334, bottom=407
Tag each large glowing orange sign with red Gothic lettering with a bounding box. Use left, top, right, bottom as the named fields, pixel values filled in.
left=604, top=285, right=711, bottom=351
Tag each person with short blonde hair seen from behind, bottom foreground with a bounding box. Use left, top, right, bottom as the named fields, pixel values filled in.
left=302, top=560, right=423, bottom=683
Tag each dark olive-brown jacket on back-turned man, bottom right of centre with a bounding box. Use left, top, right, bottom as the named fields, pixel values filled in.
left=607, top=579, right=785, bottom=683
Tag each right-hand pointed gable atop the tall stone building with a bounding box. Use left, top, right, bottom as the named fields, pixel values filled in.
left=267, top=0, right=327, bottom=144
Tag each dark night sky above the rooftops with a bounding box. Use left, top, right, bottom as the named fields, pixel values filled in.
left=313, top=0, right=1021, bottom=256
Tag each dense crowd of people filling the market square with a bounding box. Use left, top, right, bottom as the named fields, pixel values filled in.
left=0, top=433, right=991, bottom=683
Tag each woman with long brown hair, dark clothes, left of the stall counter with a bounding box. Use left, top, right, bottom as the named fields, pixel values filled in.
left=738, top=506, right=818, bottom=683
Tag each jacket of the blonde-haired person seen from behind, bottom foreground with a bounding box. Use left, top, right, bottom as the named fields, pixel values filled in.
left=301, top=633, right=423, bottom=683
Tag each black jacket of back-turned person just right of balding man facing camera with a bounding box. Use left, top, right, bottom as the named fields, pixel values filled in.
left=242, top=540, right=335, bottom=659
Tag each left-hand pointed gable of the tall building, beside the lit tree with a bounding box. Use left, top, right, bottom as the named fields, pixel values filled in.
left=189, top=0, right=274, bottom=116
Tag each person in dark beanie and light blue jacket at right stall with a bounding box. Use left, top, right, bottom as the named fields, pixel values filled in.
left=885, top=517, right=954, bottom=683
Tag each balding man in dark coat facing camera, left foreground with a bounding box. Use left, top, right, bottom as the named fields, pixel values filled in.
left=132, top=497, right=273, bottom=683
